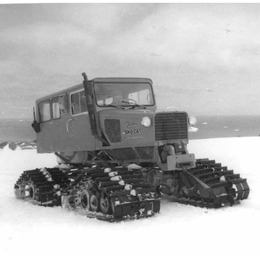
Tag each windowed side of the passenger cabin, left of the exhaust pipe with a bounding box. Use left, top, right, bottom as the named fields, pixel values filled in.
left=37, top=89, right=96, bottom=153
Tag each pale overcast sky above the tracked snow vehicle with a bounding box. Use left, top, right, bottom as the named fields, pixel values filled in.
left=0, top=4, right=260, bottom=118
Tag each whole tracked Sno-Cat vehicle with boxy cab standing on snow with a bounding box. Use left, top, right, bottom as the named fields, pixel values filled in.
left=14, top=73, right=249, bottom=221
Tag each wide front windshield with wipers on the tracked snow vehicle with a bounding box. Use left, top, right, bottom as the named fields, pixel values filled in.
left=94, top=83, right=154, bottom=107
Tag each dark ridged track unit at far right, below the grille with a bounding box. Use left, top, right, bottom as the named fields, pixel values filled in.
left=173, top=159, right=250, bottom=208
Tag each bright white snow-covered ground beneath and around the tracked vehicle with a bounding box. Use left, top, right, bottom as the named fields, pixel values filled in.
left=0, top=137, right=260, bottom=259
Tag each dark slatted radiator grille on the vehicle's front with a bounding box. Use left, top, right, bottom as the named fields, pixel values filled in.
left=155, top=112, right=188, bottom=141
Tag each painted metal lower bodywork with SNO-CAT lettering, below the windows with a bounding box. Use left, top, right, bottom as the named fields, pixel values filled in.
left=37, top=108, right=188, bottom=153
